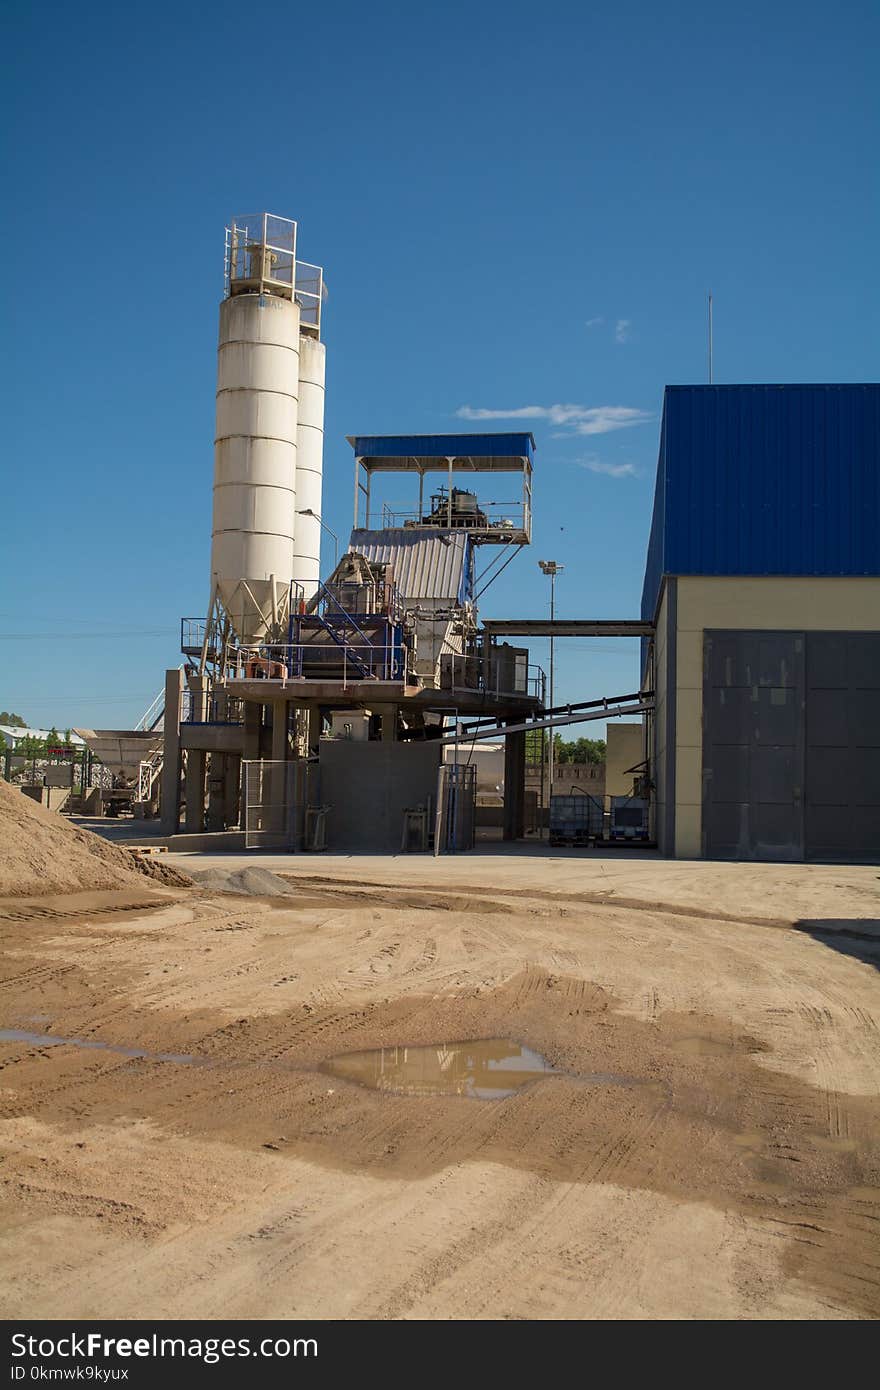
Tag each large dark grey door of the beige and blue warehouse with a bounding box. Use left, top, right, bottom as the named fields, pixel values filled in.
left=702, top=631, right=880, bottom=860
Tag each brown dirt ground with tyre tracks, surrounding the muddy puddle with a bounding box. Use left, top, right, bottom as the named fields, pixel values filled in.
left=0, top=848, right=880, bottom=1319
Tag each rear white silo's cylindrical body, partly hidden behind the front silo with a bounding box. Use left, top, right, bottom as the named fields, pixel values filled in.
left=293, top=335, right=325, bottom=599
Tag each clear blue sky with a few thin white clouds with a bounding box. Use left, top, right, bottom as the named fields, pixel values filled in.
left=0, top=0, right=880, bottom=733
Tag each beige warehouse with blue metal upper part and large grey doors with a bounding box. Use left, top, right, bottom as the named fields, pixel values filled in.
left=642, top=385, right=880, bottom=860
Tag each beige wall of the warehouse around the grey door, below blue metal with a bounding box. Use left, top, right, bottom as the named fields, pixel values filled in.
left=655, top=575, right=880, bottom=859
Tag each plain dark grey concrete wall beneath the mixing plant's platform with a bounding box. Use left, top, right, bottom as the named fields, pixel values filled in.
left=318, top=738, right=441, bottom=853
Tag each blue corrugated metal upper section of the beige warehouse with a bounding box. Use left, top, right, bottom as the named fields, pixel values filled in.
left=642, top=385, right=880, bottom=620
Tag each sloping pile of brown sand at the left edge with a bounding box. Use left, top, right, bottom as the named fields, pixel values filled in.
left=0, top=780, right=190, bottom=898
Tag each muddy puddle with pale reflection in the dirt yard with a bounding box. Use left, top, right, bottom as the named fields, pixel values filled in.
left=321, top=1038, right=555, bottom=1101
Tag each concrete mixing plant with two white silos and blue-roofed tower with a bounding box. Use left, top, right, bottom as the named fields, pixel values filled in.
left=157, top=214, right=544, bottom=851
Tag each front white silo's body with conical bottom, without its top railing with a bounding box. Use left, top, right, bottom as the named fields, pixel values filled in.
left=211, top=292, right=300, bottom=644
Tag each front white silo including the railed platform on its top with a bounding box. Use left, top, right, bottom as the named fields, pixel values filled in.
left=211, top=213, right=321, bottom=644
